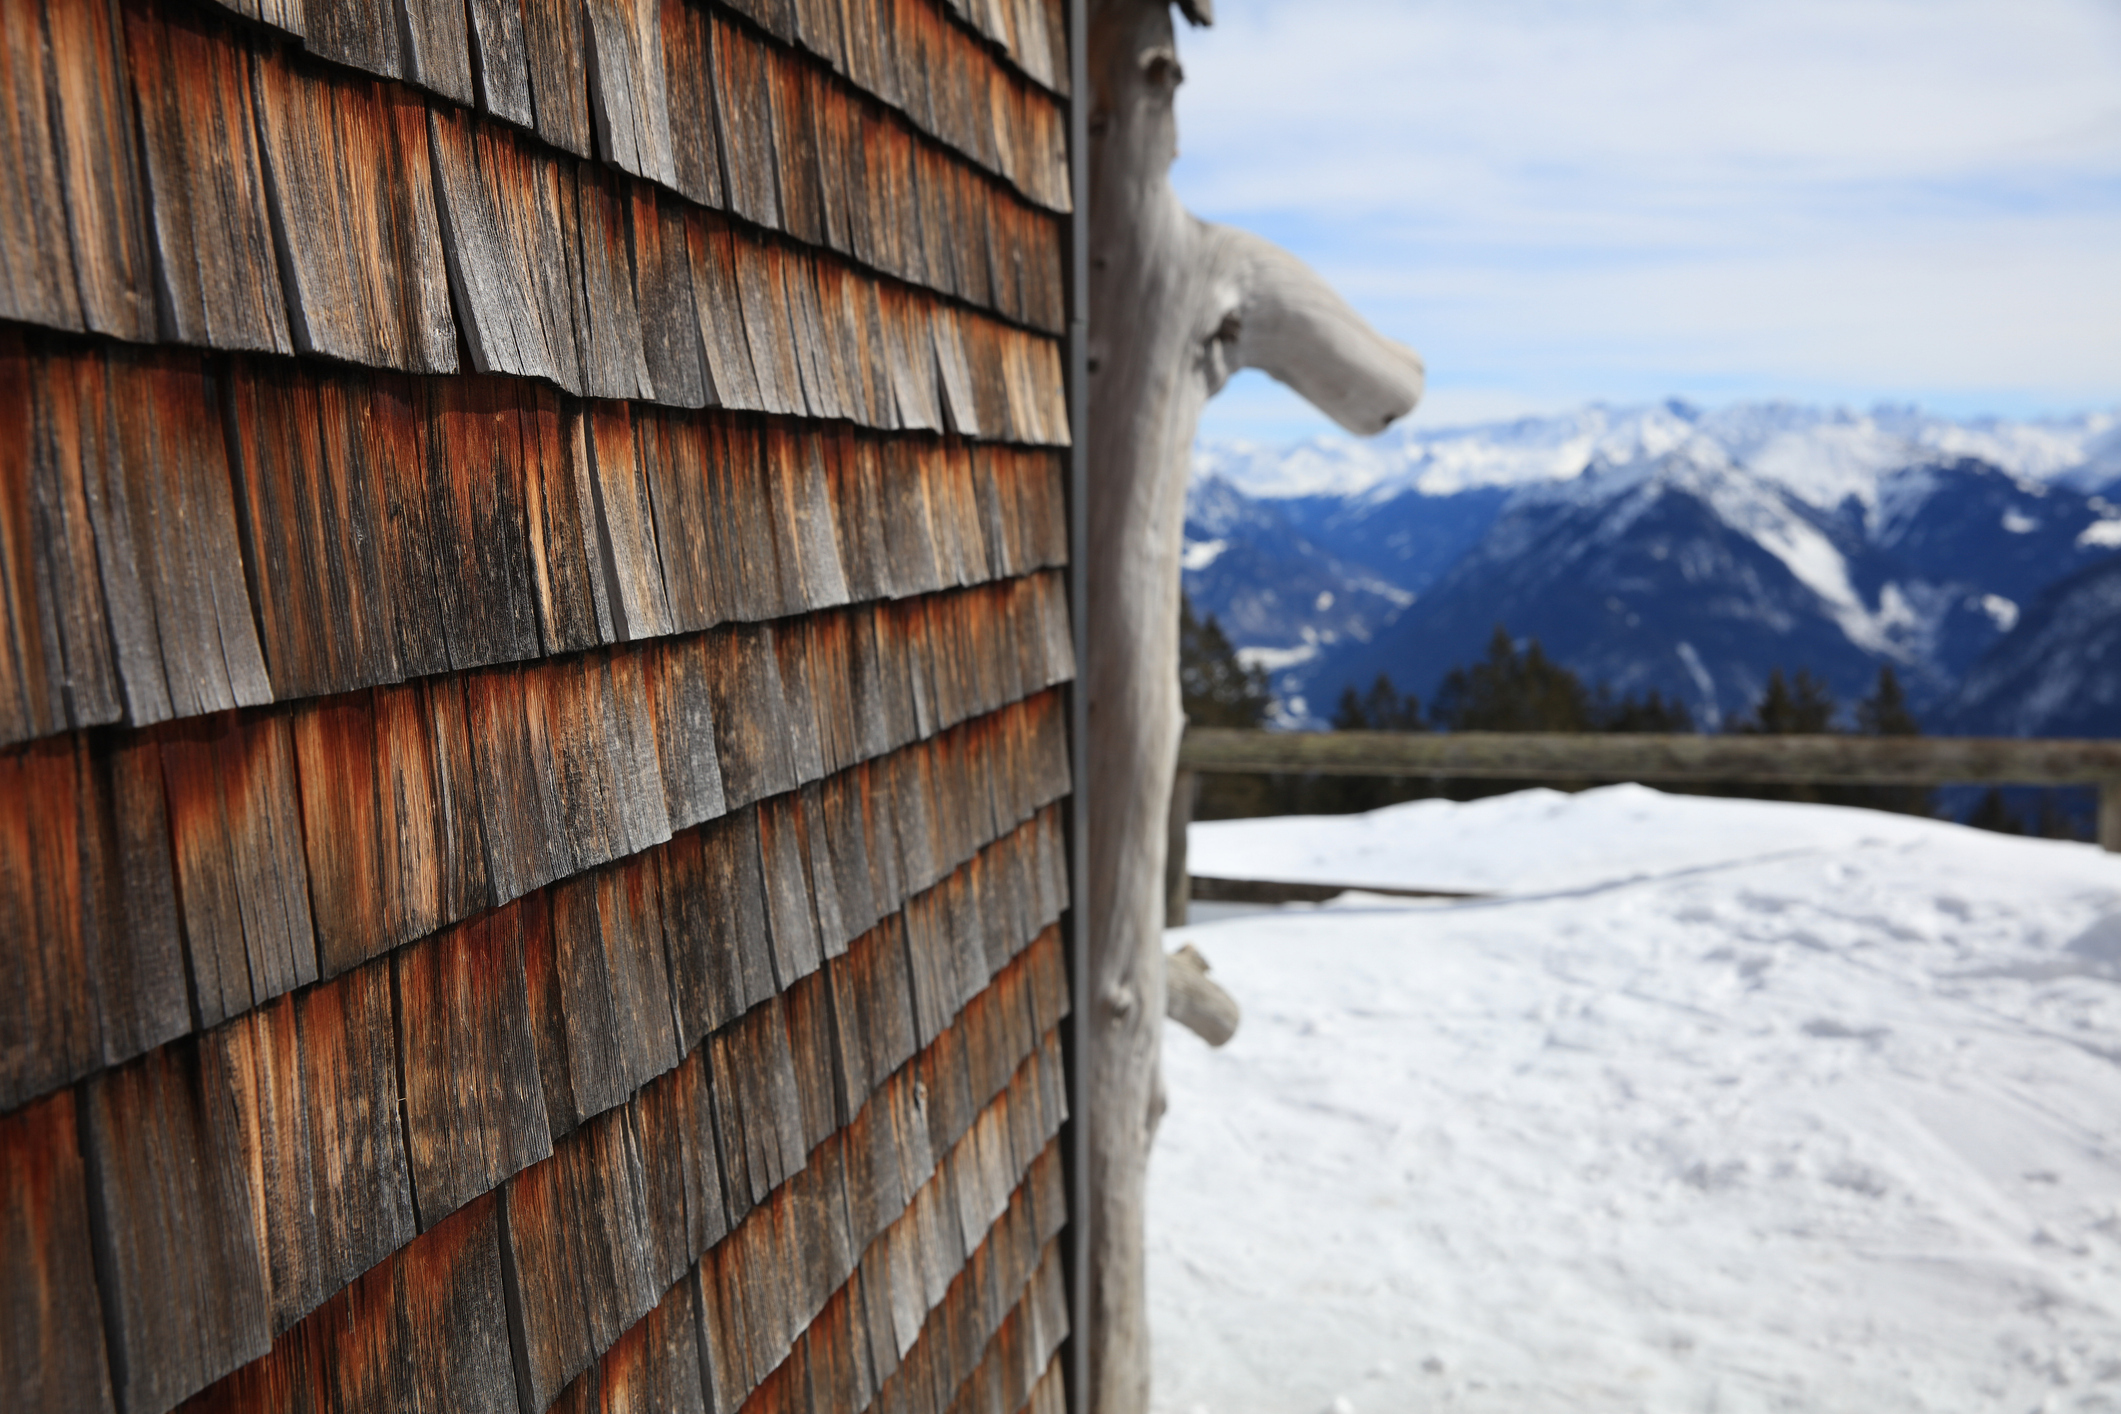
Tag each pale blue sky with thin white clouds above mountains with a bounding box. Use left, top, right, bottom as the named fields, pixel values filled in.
left=1173, top=0, right=2121, bottom=439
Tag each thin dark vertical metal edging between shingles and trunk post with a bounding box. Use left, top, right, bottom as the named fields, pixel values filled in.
left=1061, top=0, right=1092, bottom=1414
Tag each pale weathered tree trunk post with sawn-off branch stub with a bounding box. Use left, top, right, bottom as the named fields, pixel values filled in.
left=1080, top=0, right=1421, bottom=1414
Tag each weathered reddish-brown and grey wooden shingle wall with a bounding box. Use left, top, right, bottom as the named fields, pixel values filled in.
left=0, top=0, right=1075, bottom=1414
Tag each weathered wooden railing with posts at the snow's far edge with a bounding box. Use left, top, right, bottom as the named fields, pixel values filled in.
left=1167, top=727, right=2121, bottom=920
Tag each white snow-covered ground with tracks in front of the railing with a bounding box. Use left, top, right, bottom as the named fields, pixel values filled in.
left=1150, top=786, right=2121, bottom=1414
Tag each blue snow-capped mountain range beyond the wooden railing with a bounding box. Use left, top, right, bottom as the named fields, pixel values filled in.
left=1186, top=401, right=2121, bottom=733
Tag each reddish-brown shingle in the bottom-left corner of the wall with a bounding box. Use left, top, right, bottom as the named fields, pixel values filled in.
left=0, top=1090, right=115, bottom=1414
